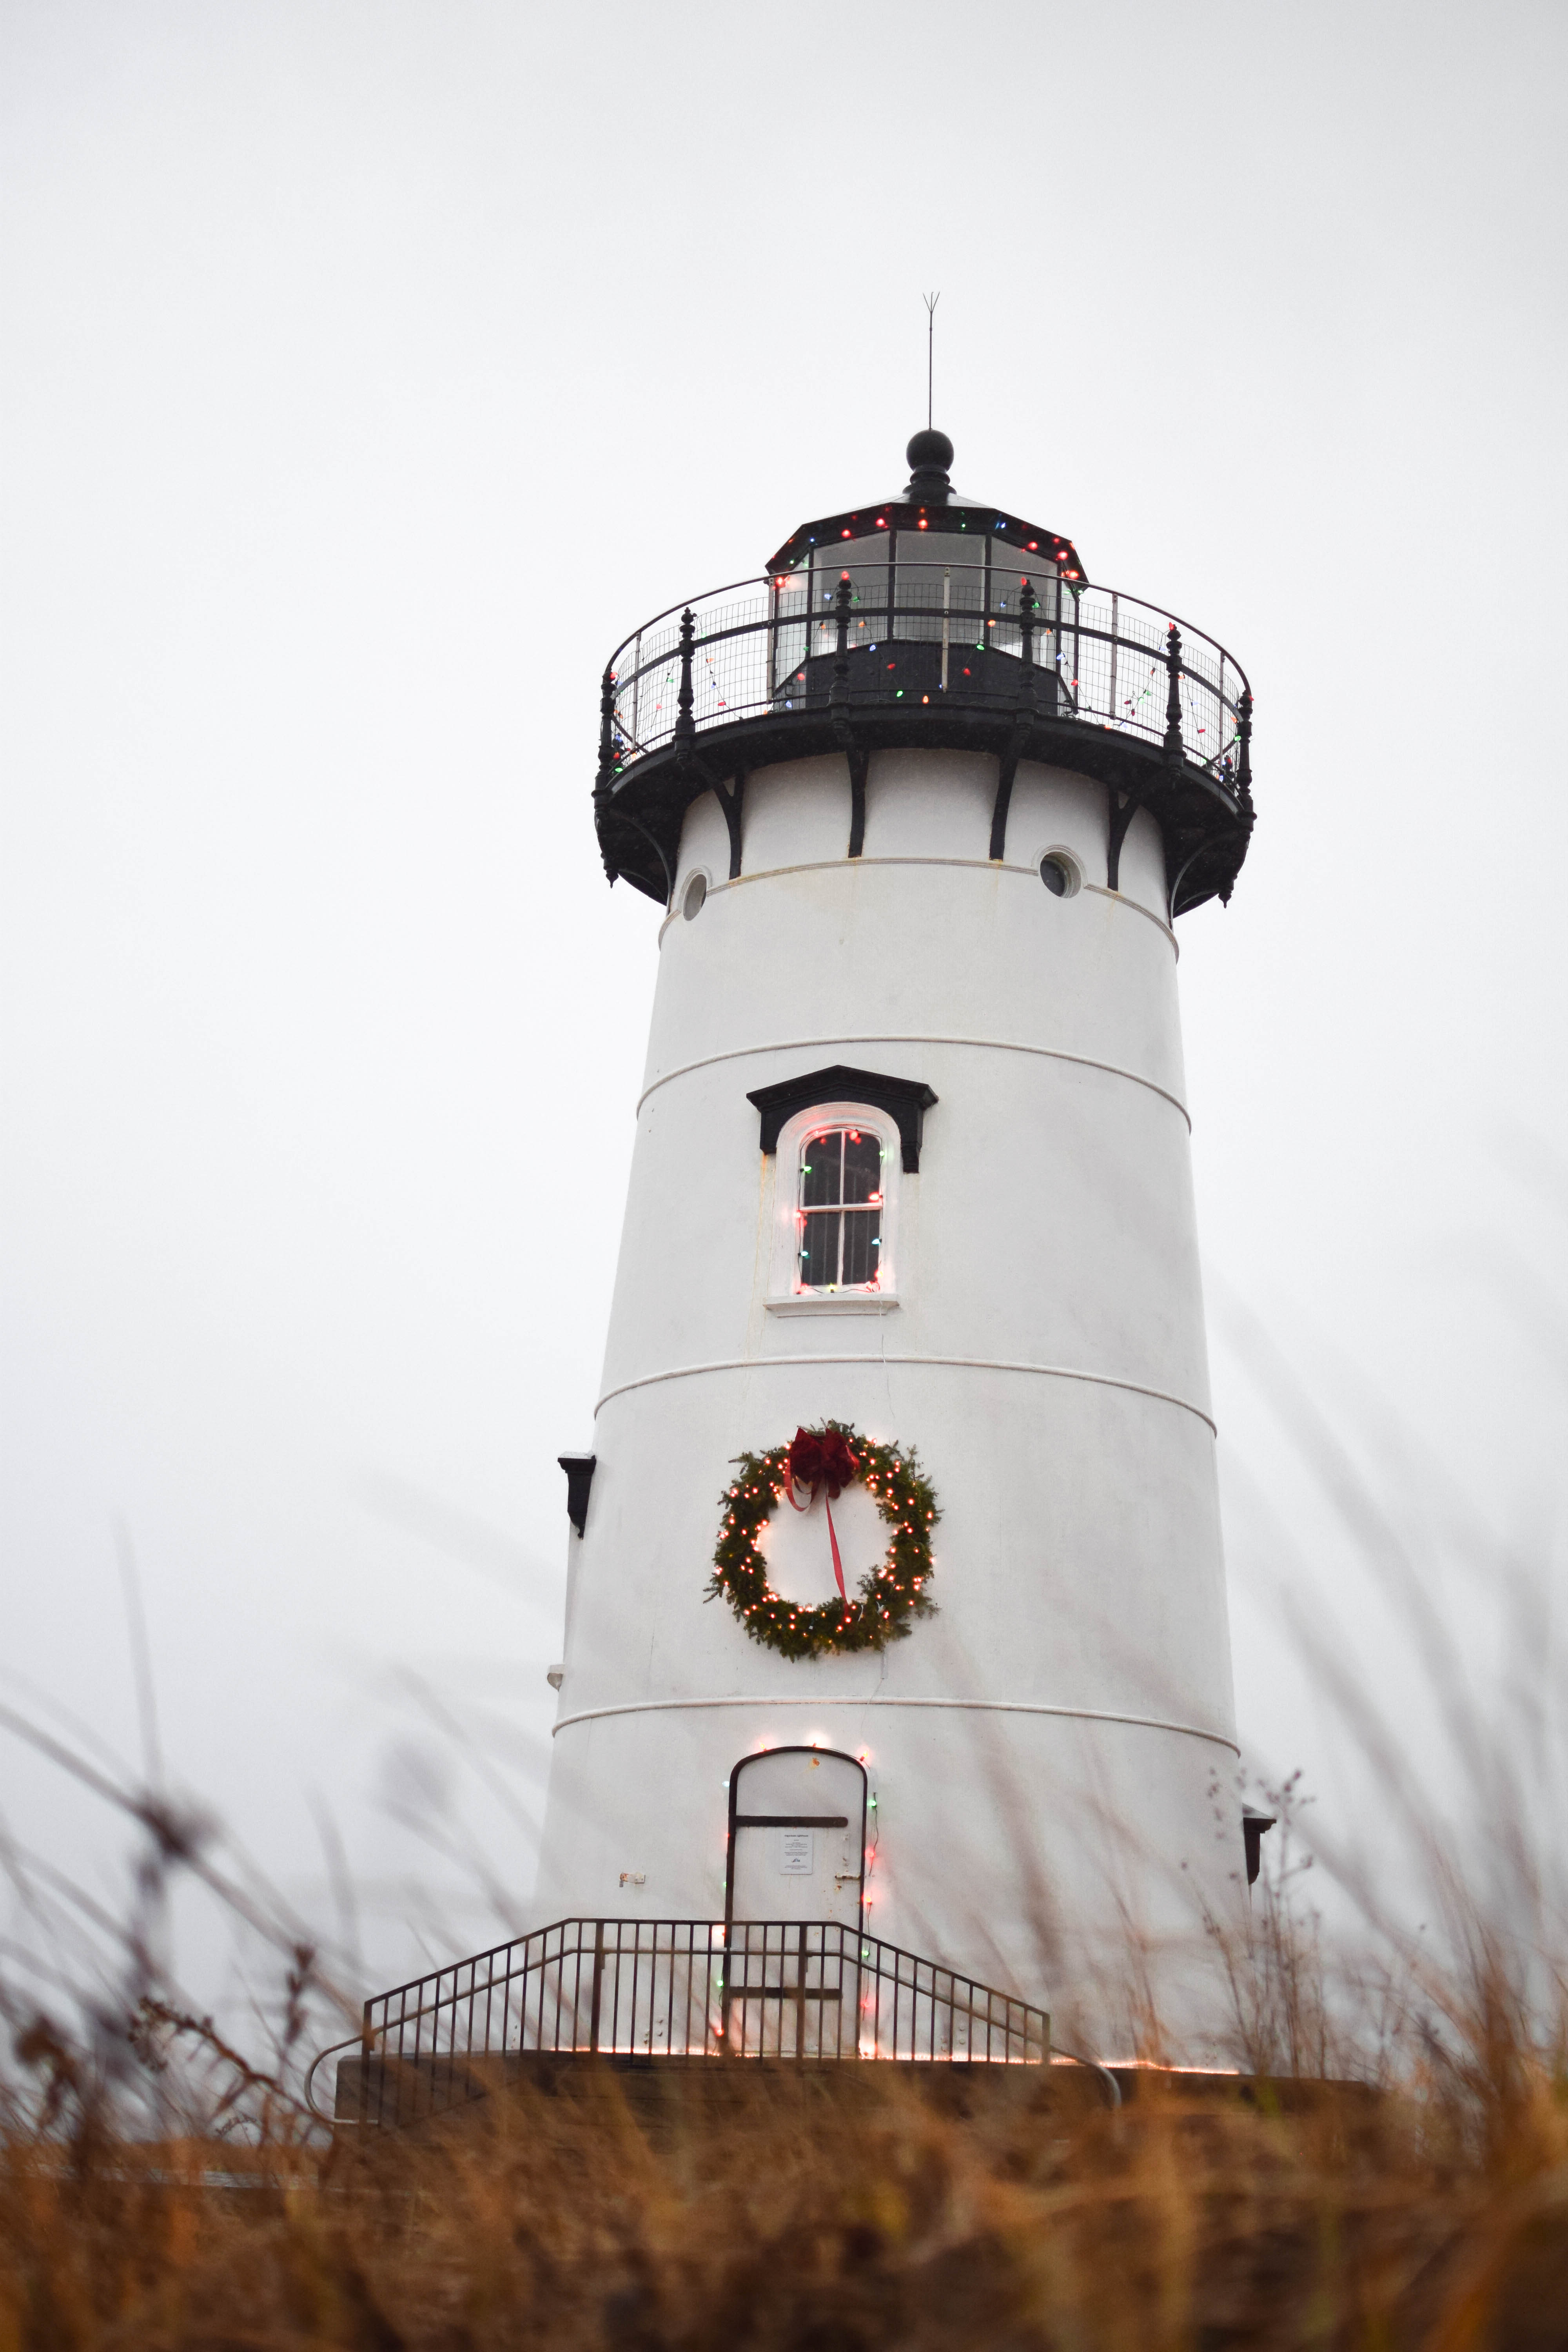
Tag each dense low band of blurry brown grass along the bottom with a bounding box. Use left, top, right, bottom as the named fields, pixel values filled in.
left=0, top=2023, right=1568, bottom=2352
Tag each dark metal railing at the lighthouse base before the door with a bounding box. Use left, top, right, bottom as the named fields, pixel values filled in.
left=313, top=1919, right=1051, bottom=2124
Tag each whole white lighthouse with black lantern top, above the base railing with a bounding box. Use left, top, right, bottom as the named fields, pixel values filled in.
left=534, top=430, right=1253, bottom=2051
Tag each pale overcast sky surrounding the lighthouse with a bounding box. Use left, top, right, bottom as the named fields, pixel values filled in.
left=0, top=0, right=1568, bottom=2023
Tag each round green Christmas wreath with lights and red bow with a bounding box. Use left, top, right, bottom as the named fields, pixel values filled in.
left=708, top=1421, right=940, bottom=1658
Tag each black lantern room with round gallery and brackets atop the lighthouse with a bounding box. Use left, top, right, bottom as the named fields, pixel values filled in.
left=595, top=430, right=1253, bottom=917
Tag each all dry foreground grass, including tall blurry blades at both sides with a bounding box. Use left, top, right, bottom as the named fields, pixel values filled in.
left=0, top=1327, right=1568, bottom=2352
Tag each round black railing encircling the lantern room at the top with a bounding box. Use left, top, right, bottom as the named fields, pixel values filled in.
left=599, top=550, right=1250, bottom=793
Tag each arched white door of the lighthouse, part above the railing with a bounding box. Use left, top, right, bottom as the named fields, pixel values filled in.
left=724, top=1748, right=865, bottom=1926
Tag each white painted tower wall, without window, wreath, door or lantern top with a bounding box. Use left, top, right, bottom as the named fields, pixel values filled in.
left=534, top=750, right=1246, bottom=2009
